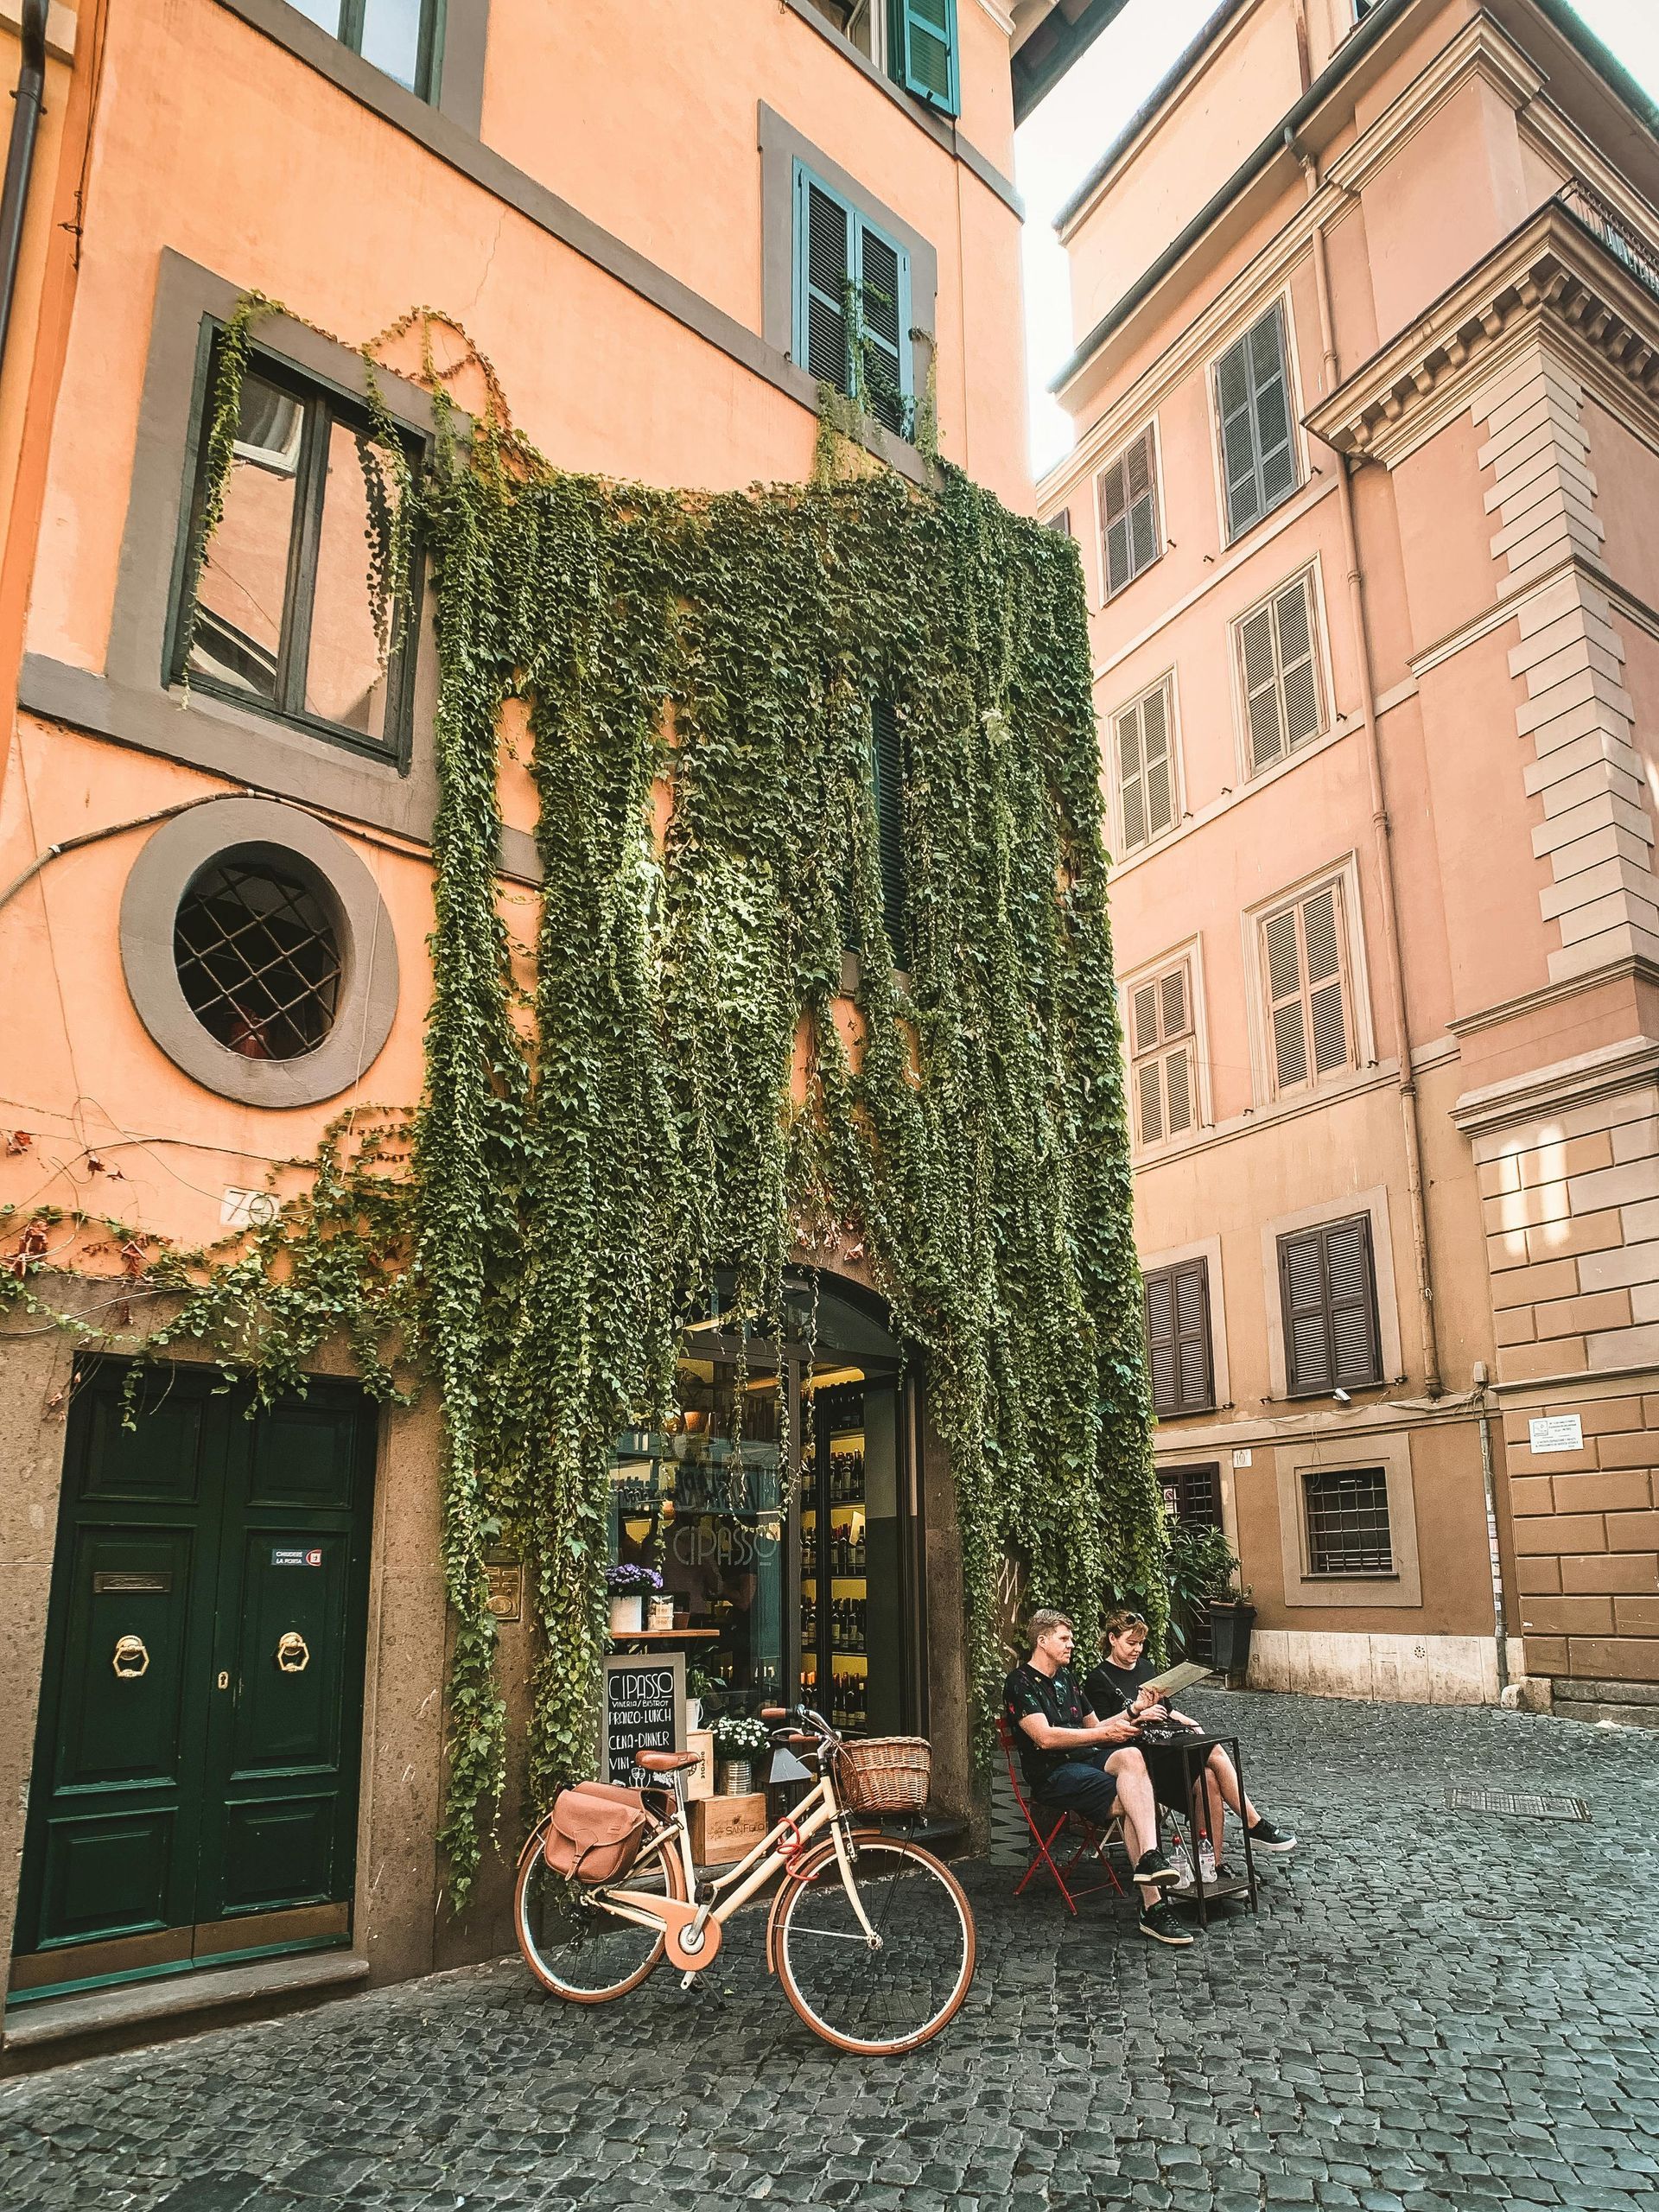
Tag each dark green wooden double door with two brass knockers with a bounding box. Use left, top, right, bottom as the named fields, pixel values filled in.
left=13, top=1363, right=374, bottom=1993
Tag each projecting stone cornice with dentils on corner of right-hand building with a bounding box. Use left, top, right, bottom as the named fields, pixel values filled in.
left=1303, top=201, right=1659, bottom=467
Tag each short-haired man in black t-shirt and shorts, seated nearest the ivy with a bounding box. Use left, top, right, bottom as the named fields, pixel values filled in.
left=1002, top=1611, right=1192, bottom=1947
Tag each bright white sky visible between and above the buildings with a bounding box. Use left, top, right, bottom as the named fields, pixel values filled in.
left=1013, top=0, right=1659, bottom=475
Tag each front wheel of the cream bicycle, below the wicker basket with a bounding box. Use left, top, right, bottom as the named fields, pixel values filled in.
left=777, top=1836, right=973, bottom=2055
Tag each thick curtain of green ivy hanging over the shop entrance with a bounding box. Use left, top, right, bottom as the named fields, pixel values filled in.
left=0, top=301, right=1164, bottom=1897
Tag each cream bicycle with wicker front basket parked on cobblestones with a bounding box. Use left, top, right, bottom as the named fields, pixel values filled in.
left=513, top=1706, right=973, bottom=2055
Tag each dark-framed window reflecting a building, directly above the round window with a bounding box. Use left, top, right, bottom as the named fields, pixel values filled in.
left=173, top=356, right=416, bottom=757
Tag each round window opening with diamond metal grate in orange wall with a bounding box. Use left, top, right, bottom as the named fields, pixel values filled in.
left=173, top=856, right=340, bottom=1059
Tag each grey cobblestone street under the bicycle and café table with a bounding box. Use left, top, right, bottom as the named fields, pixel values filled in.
left=0, top=1697, right=1659, bottom=2212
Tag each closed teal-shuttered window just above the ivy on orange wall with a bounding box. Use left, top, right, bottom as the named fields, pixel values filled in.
left=794, top=162, right=916, bottom=438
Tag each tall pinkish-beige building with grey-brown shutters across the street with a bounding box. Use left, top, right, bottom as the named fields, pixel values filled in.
left=1039, top=0, right=1659, bottom=1717
